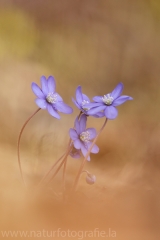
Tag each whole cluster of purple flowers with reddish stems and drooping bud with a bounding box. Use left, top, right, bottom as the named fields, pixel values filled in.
left=27, top=76, right=132, bottom=189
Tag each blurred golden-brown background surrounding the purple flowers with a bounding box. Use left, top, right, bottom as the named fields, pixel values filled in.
left=0, top=0, right=160, bottom=240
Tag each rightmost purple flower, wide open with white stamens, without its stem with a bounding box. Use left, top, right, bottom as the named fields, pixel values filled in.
left=86, top=83, right=133, bottom=119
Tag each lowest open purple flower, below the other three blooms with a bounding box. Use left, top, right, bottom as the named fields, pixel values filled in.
left=69, top=114, right=99, bottom=161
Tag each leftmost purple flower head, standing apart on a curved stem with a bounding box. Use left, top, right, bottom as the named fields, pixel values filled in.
left=31, top=76, right=73, bottom=119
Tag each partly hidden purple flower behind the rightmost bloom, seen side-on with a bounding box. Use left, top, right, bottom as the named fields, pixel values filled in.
left=72, top=86, right=104, bottom=118
